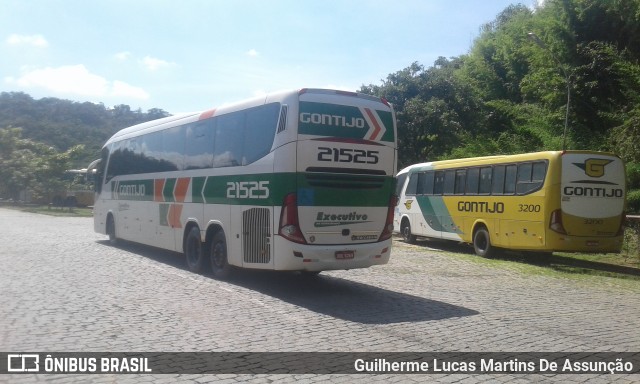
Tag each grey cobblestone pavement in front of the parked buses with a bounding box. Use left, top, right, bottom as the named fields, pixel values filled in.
left=0, top=209, right=640, bottom=383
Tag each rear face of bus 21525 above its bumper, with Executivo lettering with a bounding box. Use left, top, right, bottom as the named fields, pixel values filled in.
left=297, top=91, right=396, bottom=245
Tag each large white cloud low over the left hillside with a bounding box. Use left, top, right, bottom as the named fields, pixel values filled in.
left=5, top=64, right=149, bottom=100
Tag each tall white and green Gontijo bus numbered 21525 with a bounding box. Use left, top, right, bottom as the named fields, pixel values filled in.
left=94, top=89, right=397, bottom=277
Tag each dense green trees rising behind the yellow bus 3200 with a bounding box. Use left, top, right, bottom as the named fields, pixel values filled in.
left=361, top=0, right=640, bottom=167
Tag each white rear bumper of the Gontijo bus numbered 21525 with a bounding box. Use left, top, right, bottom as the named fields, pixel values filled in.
left=274, top=236, right=392, bottom=272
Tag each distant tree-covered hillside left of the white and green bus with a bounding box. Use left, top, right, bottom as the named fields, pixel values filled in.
left=0, top=92, right=169, bottom=202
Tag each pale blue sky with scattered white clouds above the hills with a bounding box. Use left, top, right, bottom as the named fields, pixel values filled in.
left=0, top=0, right=534, bottom=114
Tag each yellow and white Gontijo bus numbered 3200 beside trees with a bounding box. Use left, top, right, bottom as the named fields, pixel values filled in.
left=394, top=151, right=626, bottom=257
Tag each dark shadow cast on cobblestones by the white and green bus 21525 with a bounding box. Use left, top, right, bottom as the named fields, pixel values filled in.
left=100, top=241, right=478, bottom=324
